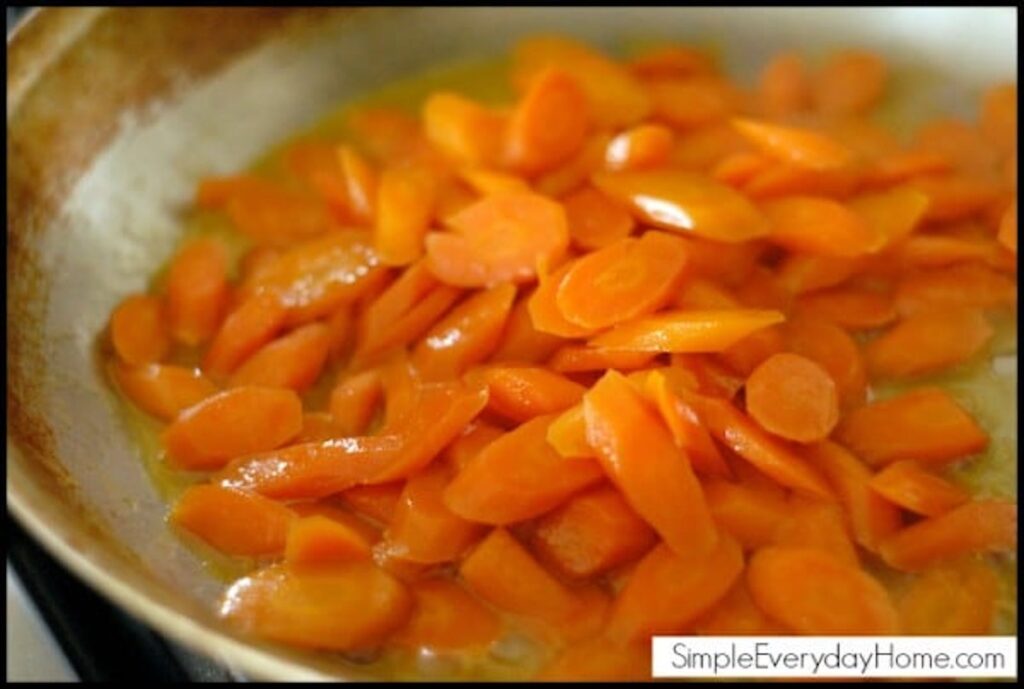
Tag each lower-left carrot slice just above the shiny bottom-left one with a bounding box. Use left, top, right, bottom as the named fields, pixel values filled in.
left=170, top=484, right=295, bottom=557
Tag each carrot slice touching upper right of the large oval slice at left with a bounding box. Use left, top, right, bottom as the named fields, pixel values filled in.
left=230, top=322, right=331, bottom=392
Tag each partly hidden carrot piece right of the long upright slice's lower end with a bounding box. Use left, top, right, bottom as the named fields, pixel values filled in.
left=705, top=480, right=788, bottom=550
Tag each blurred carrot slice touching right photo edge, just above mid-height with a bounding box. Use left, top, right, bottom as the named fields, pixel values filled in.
left=896, top=263, right=1017, bottom=314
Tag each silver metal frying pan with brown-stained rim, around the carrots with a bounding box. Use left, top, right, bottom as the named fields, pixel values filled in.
left=7, top=7, right=1017, bottom=680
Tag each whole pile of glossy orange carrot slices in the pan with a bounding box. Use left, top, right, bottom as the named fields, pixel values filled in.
left=110, top=36, right=1017, bottom=679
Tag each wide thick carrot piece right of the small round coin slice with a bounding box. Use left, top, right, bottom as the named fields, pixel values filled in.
left=836, top=387, right=988, bottom=467
